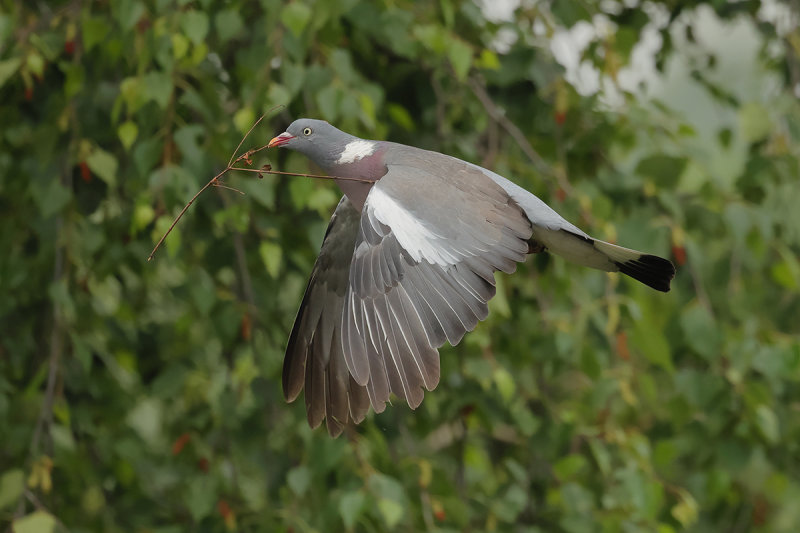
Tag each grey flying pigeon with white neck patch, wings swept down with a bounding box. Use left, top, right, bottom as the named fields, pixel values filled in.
left=269, top=118, right=675, bottom=436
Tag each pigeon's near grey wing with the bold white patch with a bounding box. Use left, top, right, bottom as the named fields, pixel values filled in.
left=341, top=157, right=532, bottom=412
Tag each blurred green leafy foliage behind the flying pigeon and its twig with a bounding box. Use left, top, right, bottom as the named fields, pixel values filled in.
left=0, top=0, right=800, bottom=533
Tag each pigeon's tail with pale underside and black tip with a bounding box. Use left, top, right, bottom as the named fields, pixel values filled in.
left=532, top=227, right=675, bottom=292
